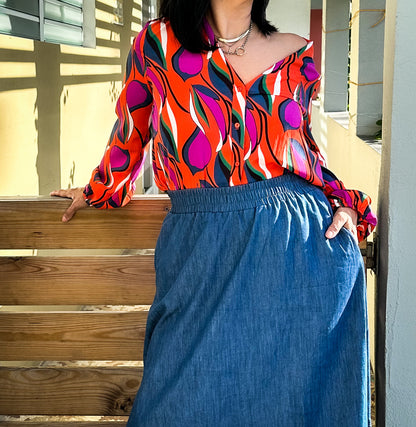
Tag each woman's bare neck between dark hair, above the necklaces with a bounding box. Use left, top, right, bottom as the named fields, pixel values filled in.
left=208, top=0, right=253, bottom=38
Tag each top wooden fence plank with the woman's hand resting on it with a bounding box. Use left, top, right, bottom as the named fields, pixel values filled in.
left=0, top=196, right=170, bottom=249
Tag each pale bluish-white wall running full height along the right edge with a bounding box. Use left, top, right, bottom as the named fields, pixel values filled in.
left=377, top=0, right=416, bottom=427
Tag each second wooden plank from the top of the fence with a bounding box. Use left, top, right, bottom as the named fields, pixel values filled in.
left=0, top=255, right=155, bottom=305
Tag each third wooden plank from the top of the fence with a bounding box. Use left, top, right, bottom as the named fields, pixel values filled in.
left=0, top=311, right=147, bottom=361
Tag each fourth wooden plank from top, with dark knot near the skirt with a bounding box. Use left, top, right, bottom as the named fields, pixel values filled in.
left=0, top=367, right=143, bottom=416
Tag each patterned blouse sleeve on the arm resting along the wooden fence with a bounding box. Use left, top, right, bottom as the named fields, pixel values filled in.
left=84, top=28, right=153, bottom=208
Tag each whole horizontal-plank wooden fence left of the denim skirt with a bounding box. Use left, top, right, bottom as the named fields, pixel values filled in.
left=0, top=196, right=170, bottom=427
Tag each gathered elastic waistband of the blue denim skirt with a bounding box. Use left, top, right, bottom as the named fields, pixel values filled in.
left=168, top=173, right=322, bottom=213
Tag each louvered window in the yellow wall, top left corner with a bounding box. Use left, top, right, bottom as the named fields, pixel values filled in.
left=0, top=0, right=95, bottom=47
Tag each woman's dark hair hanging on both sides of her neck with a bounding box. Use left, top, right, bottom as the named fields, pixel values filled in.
left=159, top=0, right=277, bottom=53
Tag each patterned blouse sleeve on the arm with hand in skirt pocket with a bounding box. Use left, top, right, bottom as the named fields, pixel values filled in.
left=302, top=55, right=377, bottom=241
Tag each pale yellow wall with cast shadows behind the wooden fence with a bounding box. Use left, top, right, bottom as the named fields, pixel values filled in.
left=0, top=0, right=144, bottom=195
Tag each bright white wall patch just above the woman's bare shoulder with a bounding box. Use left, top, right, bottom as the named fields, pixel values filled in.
left=267, top=0, right=311, bottom=38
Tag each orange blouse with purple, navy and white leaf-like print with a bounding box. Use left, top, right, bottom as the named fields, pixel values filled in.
left=84, top=19, right=377, bottom=240
